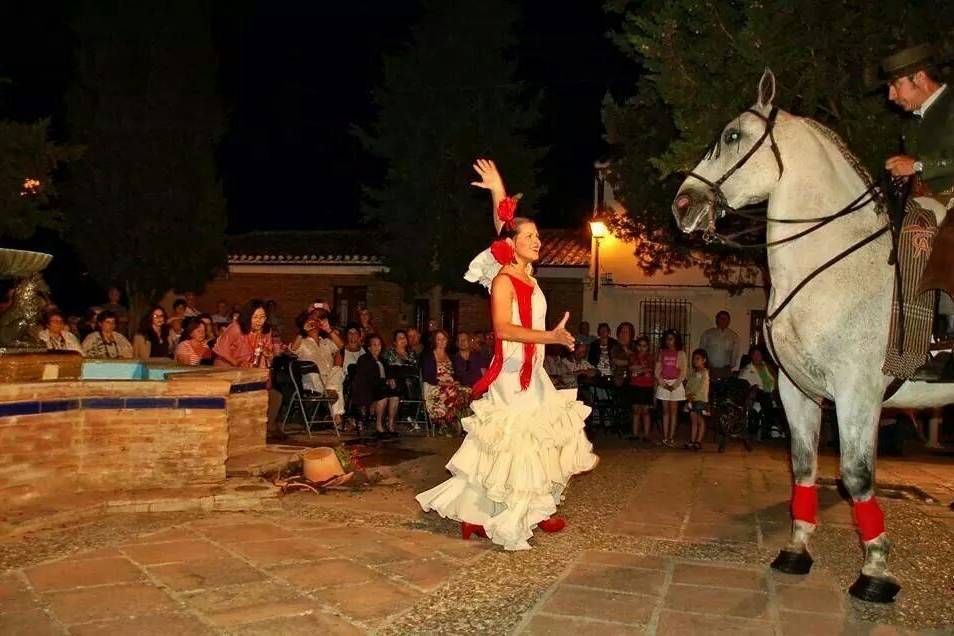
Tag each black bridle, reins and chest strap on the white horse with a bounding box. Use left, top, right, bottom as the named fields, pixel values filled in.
left=688, top=106, right=892, bottom=400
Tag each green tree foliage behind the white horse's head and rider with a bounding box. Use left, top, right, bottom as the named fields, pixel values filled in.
left=603, top=0, right=954, bottom=284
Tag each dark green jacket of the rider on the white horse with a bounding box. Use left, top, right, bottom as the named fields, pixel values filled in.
left=904, top=86, right=954, bottom=198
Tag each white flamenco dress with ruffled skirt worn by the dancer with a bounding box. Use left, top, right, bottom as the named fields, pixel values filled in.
left=417, top=250, right=599, bottom=550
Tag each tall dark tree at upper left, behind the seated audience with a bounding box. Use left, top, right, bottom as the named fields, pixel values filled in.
left=67, top=0, right=226, bottom=318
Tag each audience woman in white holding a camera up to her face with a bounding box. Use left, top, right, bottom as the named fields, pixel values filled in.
left=294, top=309, right=344, bottom=426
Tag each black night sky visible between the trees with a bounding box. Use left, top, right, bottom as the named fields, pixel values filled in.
left=7, top=0, right=636, bottom=232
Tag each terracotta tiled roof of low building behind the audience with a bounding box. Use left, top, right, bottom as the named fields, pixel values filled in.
left=225, top=229, right=590, bottom=267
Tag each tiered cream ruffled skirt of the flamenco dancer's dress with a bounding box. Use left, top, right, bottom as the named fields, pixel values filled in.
left=417, top=389, right=598, bottom=550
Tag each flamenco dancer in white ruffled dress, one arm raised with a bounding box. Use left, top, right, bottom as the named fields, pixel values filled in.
left=417, top=159, right=599, bottom=550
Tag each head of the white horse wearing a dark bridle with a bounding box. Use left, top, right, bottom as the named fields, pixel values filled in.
left=672, top=69, right=783, bottom=233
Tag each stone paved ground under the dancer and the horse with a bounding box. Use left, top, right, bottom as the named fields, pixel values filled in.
left=0, top=440, right=954, bottom=636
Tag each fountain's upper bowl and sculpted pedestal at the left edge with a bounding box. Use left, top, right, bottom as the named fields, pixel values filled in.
left=0, top=248, right=53, bottom=355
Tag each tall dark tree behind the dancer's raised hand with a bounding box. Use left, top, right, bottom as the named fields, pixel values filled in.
left=357, top=0, right=545, bottom=293
